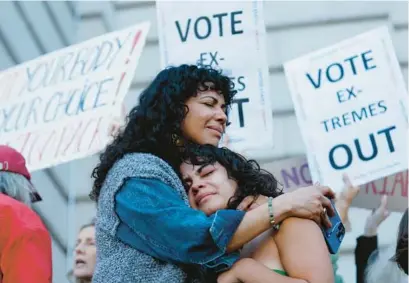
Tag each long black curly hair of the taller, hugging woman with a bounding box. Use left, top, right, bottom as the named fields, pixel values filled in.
left=90, top=65, right=237, bottom=201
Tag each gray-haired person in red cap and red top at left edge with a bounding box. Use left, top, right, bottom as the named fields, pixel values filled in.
left=0, top=145, right=52, bottom=283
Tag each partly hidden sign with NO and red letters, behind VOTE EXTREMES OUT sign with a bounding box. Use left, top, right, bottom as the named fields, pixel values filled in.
left=261, top=156, right=408, bottom=212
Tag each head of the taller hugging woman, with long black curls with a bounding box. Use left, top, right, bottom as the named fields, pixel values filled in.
left=90, top=65, right=237, bottom=200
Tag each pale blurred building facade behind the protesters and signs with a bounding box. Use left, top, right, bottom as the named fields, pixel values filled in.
left=0, top=1, right=408, bottom=283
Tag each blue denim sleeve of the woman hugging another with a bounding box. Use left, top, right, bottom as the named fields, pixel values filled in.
left=115, top=178, right=245, bottom=272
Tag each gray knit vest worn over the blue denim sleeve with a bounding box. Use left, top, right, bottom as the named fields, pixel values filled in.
left=92, top=153, right=188, bottom=283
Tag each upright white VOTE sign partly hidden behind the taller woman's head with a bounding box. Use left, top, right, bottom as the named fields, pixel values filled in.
left=156, top=1, right=273, bottom=151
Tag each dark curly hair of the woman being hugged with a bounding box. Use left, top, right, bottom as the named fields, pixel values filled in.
left=183, top=145, right=283, bottom=209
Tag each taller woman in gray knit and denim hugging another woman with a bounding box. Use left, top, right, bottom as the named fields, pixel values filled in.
left=90, top=65, right=334, bottom=283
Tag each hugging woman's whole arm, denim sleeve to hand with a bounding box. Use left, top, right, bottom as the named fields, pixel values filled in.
left=116, top=178, right=332, bottom=268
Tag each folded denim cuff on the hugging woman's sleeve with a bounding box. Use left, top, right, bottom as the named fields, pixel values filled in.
left=210, top=209, right=245, bottom=252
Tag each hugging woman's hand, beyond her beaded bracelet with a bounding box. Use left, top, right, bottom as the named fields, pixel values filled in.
left=276, top=185, right=335, bottom=228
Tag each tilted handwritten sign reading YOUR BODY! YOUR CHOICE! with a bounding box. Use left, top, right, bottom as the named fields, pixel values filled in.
left=0, top=23, right=150, bottom=171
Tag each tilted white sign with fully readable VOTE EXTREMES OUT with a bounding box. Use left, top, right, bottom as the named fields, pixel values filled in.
left=284, top=27, right=408, bottom=193
